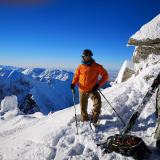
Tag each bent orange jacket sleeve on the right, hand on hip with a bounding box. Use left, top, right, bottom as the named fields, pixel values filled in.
left=98, top=65, right=109, bottom=87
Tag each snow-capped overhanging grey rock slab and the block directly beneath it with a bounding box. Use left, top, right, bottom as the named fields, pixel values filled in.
left=127, top=14, right=160, bottom=63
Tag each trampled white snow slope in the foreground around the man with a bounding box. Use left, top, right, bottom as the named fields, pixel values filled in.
left=0, top=55, right=160, bottom=160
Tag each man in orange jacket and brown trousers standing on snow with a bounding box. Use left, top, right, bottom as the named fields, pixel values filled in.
left=70, top=49, right=109, bottom=130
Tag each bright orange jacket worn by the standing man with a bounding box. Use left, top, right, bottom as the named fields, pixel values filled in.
left=72, top=61, right=109, bottom=92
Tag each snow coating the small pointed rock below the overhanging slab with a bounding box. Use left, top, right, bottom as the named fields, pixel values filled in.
left=116, top=60, right=134, bottom=83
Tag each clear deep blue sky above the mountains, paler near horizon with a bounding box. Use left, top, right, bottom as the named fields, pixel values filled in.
left=0, top=0, right=160, bottom=70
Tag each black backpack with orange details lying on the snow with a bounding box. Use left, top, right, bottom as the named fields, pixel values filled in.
left=98, top=134, right=152, bottom=160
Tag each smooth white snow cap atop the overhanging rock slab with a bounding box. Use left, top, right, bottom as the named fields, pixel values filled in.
left=131, top=14, right=160, bottom=40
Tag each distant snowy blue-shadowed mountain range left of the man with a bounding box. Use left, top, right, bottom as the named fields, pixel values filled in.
left=0, top=66, right=79, bottom=114
